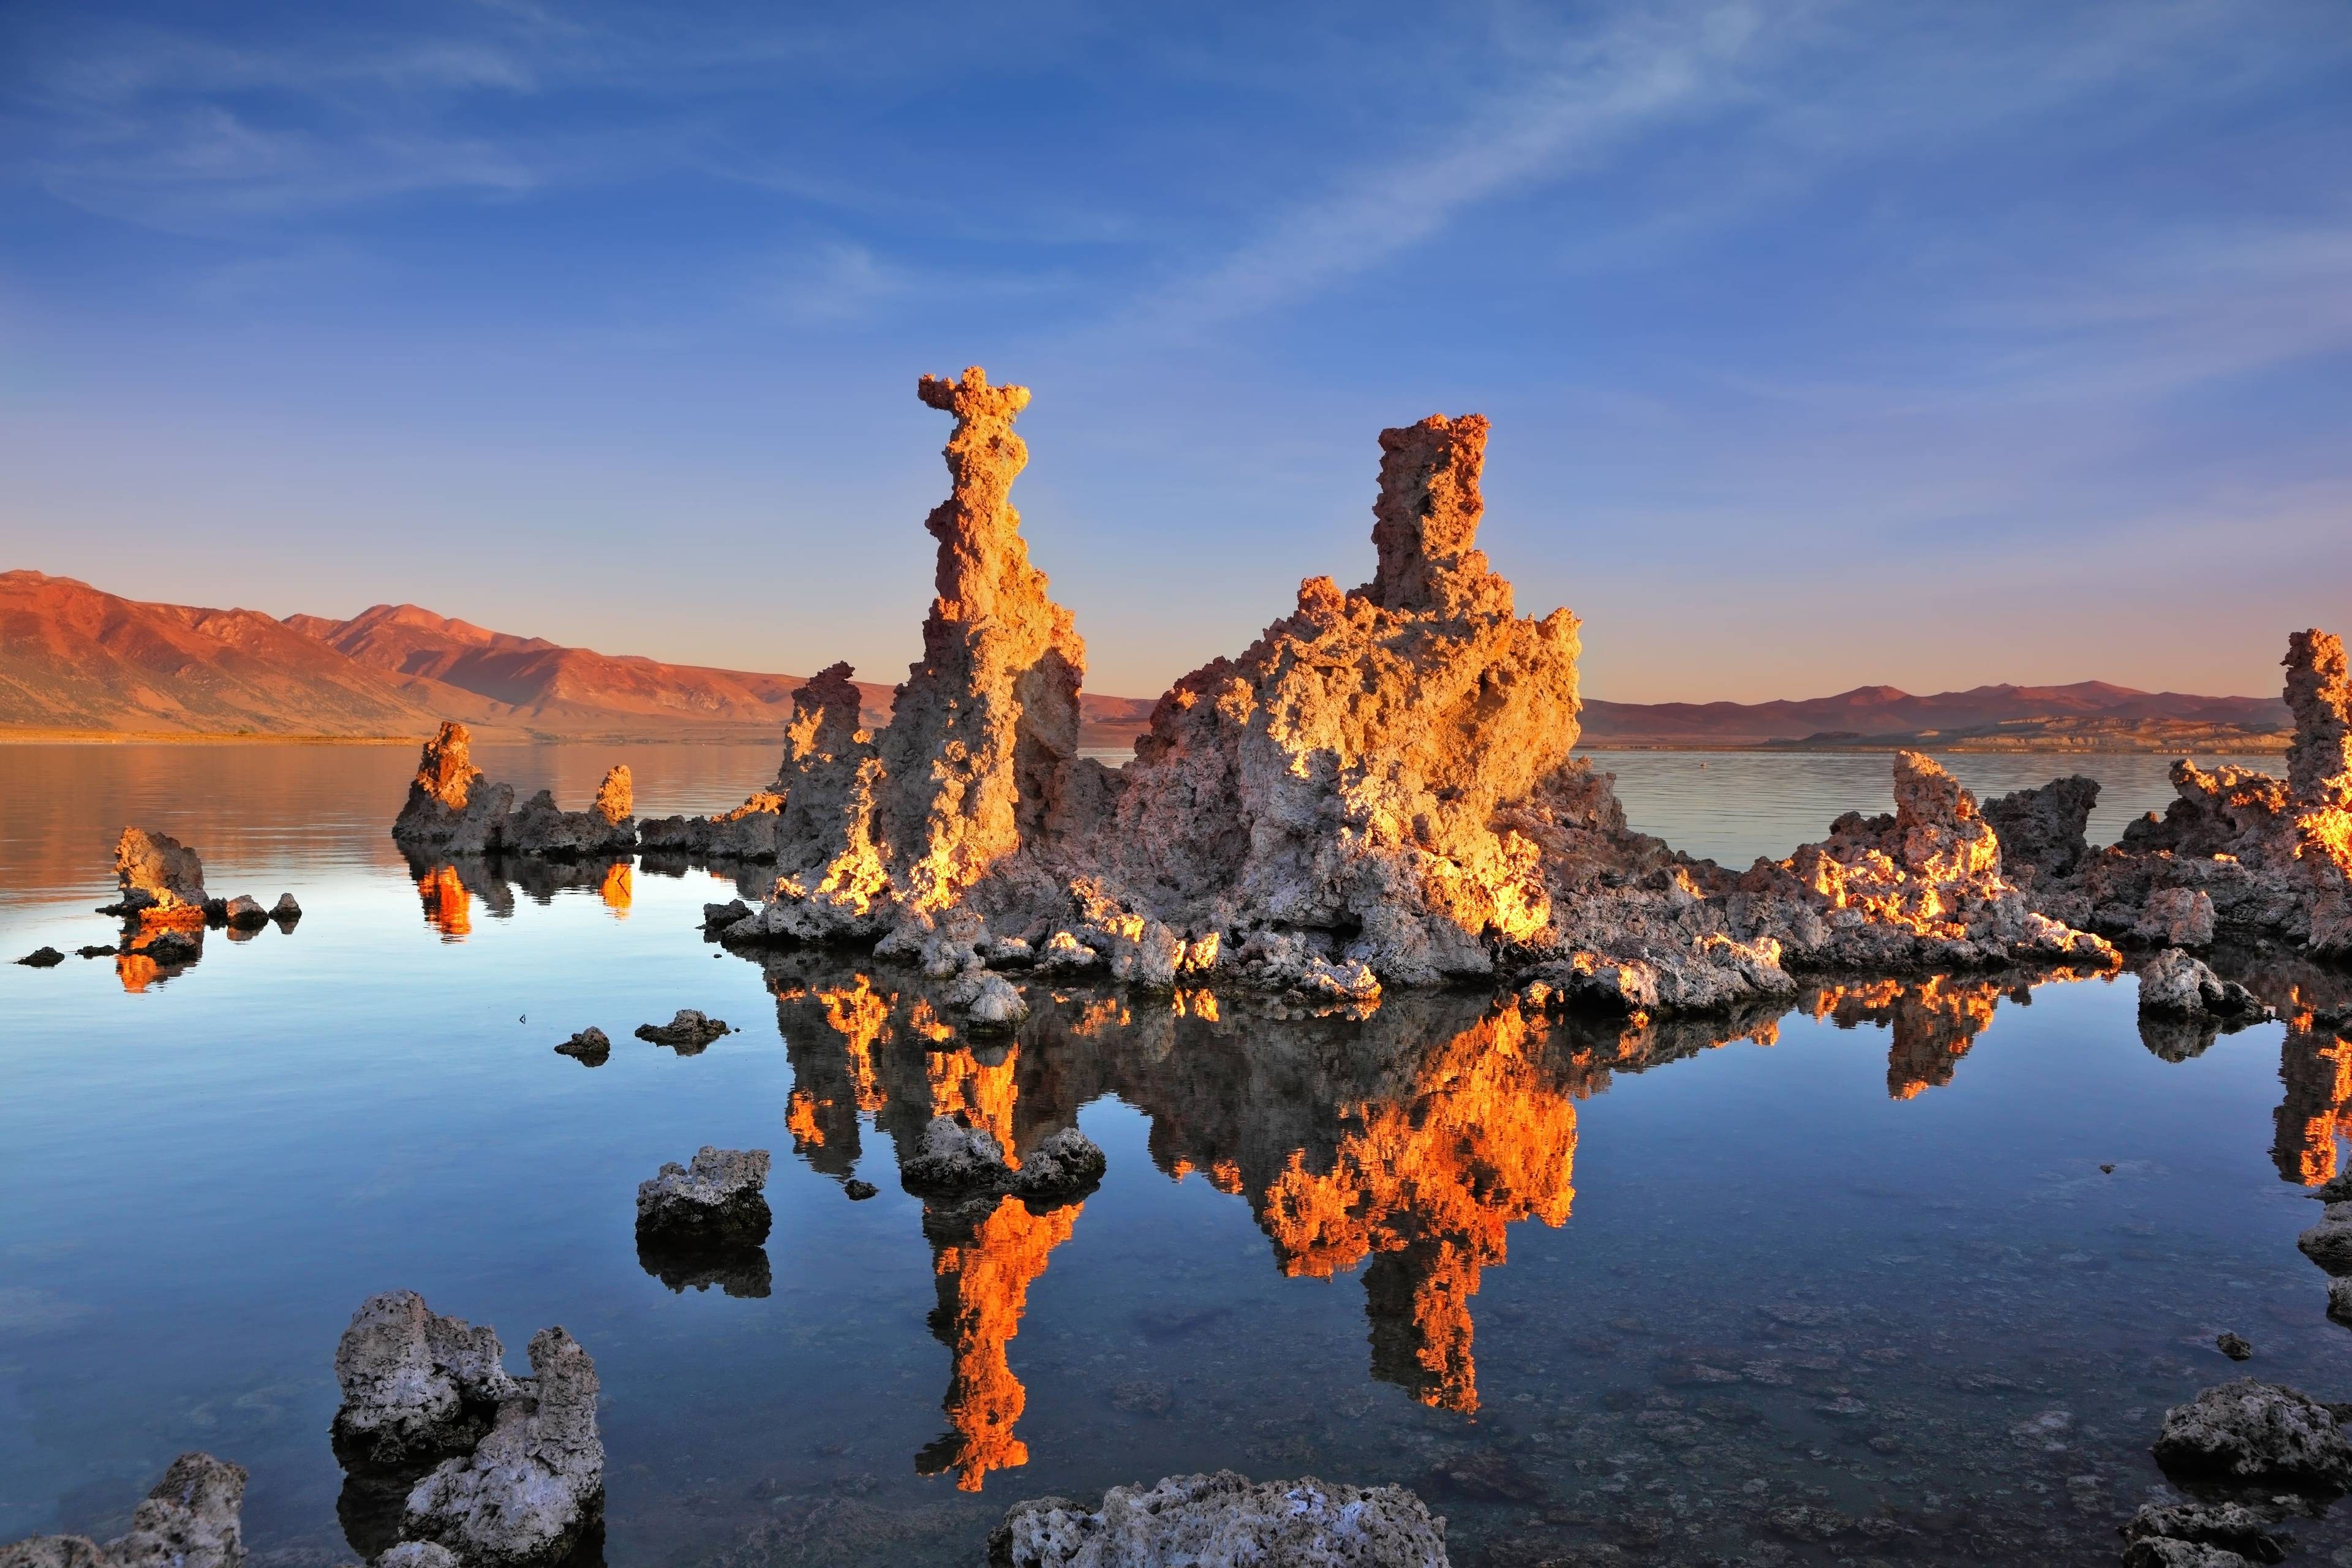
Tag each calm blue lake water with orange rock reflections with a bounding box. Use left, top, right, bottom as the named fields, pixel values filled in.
left=0, top=745, right=2352, bottom=1568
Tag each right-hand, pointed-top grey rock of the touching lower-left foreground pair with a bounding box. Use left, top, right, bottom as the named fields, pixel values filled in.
left=402, top=1329, right=605, bottom=1568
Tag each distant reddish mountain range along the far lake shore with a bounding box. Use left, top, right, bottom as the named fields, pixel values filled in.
left=0, top=571, right=2286, bottom=752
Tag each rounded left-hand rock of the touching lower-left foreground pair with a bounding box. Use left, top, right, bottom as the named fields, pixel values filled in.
left=334, top=1291, right=515, bottom=1464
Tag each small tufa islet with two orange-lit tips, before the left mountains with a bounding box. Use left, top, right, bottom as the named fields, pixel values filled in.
left=393, top=722, right=638, bottom=861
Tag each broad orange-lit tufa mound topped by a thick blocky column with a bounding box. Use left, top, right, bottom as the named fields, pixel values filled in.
left=1068, top=414, right=1578, bottom=982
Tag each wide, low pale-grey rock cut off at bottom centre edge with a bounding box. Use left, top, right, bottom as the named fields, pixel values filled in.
left=988, top=1469, right=1449, bottom=1568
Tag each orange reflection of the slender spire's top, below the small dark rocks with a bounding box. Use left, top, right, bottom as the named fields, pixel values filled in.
left=915, top=1197, right=1082, bottom=1493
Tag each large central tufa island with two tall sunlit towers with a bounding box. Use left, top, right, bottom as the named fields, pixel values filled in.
left=677, top=369, right=2117, bottom=1030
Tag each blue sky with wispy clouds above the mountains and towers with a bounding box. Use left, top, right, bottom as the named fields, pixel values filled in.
left=0, top=0, right=2352, bottom=701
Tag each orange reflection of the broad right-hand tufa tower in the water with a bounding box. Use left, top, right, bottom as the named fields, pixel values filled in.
left=1261, top=1009, right=1576, bottom=1411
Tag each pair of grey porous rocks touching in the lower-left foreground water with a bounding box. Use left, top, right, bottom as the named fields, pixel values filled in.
left=334, top=1291, right=605, bottom=1568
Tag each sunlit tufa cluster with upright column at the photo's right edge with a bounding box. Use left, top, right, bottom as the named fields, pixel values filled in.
left=2004, top=630, right=2352, bottom=957
